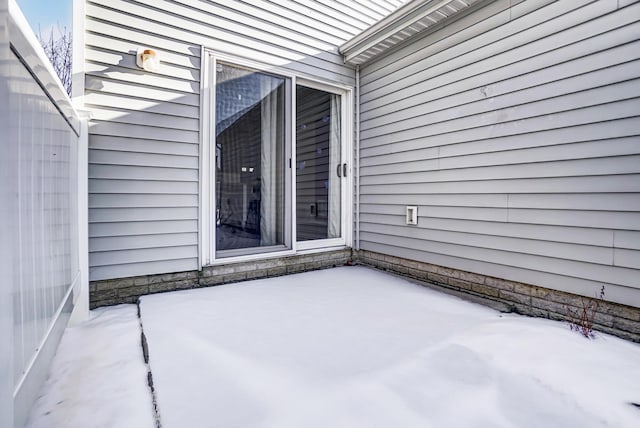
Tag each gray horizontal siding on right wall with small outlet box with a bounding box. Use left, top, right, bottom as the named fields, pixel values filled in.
left=360, top=0, right=640, bottom=306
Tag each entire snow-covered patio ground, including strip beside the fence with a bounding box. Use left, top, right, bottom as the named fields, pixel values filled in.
left=29, top=267, right=640, bottom=428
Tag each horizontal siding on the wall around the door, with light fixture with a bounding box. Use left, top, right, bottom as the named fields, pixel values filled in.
left=84, top=0, right=401, bottom=280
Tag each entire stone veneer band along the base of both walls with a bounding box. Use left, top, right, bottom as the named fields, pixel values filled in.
left=89, top=249, right=640, bottom=342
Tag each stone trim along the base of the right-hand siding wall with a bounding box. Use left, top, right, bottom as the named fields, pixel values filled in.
left=354, top=250, right=640, bottom=342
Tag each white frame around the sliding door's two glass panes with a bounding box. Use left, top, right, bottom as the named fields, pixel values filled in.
left=198, top=47, right=355, bottom=269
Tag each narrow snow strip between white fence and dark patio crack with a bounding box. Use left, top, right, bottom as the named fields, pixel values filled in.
left=27, top=305, right=155, bottom=428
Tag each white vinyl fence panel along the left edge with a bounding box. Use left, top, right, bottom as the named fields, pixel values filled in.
left=0, top=0, right=86, bottom=427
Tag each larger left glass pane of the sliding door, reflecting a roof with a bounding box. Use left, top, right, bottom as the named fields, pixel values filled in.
left=214, top=63, right=287, bottom=257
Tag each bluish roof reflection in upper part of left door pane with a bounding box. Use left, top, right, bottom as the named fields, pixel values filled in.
left=216, top=69, right=284, bottom=135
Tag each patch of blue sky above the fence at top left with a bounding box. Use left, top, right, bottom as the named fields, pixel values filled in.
left=17, top=0, right=73, bottom=37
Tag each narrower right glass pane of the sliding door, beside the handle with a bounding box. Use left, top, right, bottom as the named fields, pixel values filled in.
left=296, top=85, right=345, bottom=242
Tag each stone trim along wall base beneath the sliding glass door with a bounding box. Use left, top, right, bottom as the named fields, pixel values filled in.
left=89, top=248, right=351, bottom=309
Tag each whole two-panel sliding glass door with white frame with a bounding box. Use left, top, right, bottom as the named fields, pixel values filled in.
left=208, top=57, right=350, bottom=265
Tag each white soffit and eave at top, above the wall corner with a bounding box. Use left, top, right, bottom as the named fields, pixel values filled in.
left=339, top=0, right=486, bottom=65
